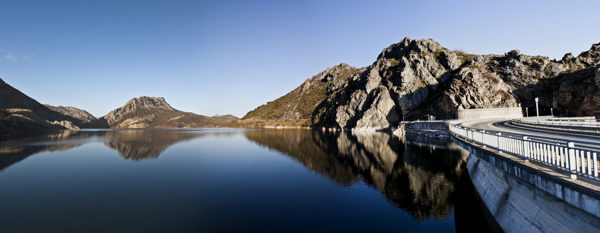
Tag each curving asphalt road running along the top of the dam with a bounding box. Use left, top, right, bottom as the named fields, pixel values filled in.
left=463, top=120, right=600, bottom=144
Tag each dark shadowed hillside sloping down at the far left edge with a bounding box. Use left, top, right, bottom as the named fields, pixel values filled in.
left=0, top=79, right=91, bottom=134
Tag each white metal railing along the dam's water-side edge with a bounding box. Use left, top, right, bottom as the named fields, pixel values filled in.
left=449, top=124, right=600, bottom=180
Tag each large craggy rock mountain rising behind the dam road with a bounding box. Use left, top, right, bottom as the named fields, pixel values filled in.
left=243, top=37, right=600, bottom=130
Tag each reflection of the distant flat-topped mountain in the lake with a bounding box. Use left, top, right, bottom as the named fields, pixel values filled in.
left=104, top=129, right=201, bottom=161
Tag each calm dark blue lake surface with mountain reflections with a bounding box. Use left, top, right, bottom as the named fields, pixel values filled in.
left=0, top=129, right=489, bottom=232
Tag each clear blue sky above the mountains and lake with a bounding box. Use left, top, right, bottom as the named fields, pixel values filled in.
left=0, top=0, right=600, bottom=117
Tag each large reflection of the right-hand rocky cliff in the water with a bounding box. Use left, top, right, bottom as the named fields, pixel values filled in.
left=246, top=130, right=466, bottom=219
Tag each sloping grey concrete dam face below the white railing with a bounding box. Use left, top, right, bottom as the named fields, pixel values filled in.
left=452, top=137, right=600, bottom=232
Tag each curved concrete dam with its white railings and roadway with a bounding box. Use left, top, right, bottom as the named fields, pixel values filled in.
left=406, top=117, right=600, bottom=232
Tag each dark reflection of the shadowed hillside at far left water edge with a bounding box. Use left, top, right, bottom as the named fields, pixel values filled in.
left=0, top=131, right=88, bottom=172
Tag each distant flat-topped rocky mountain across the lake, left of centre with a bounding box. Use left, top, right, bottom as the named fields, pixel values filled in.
left=95, top=96, right=237, bottom=128
